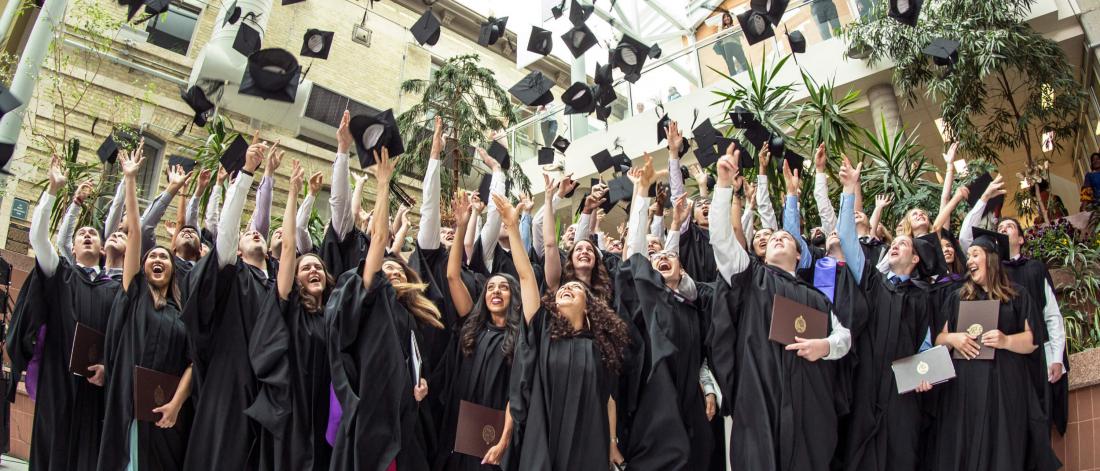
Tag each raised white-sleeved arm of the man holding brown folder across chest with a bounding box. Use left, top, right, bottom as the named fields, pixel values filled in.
left=708, top=145, right=749, bottom=283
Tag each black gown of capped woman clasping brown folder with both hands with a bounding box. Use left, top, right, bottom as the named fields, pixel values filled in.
left=925, top=286, right=1062, bottom=471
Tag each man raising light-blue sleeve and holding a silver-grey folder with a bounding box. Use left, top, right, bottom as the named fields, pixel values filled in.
left=837, top=160, right=939, bottom=471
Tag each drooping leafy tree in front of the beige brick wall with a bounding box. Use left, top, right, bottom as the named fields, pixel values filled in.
left=395, top=54, right=531, bottom=207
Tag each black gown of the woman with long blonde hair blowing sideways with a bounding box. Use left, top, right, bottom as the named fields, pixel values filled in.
left=325, top=272, right=431, bottom=471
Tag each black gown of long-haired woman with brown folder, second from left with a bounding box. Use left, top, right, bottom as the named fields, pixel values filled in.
left=98, top=273, right=194, bottom=471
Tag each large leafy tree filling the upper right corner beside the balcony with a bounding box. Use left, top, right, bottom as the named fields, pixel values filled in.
left=845, top=0, right=1085, bottom=168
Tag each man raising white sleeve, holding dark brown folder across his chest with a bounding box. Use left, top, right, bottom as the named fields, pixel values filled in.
left=710, top=145, right=851, bottom=470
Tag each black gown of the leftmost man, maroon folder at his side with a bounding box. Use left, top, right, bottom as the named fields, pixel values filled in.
left=7, top=258, right=119, bottom=471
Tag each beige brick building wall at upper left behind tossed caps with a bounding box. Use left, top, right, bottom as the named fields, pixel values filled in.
left=0, top=0, right=560, bottom=251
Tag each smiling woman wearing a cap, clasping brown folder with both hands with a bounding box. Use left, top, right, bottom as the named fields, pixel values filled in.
left=924, top=232, right=1062, bottom=471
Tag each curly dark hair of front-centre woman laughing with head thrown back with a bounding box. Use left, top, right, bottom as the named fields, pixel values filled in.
left=542, top=287, right=630, bottom=374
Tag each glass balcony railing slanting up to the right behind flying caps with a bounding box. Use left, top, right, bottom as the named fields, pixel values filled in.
left=507, top=0, right=871, bottom=166
